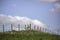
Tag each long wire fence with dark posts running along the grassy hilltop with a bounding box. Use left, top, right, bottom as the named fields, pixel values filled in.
left=0, top=24, right=59, bottom=33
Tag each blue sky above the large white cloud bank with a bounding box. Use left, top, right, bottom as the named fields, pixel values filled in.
left=0, top=0, right=60, bottom=34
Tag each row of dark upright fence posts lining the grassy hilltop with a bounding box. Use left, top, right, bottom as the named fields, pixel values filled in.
left=0, top=24, right=58, bottom=32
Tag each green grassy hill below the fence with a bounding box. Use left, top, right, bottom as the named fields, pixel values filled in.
left=0, top=30, right=60, bottom=40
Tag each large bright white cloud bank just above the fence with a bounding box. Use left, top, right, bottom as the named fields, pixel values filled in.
left=0, top=14, right=46, bottom=27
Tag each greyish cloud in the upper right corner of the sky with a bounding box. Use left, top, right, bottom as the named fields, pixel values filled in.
left=36, top=0, right=60, bottom=13
